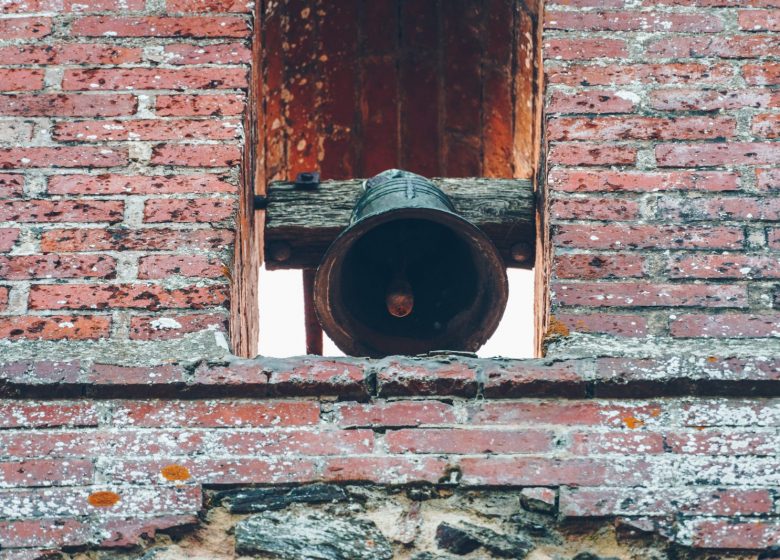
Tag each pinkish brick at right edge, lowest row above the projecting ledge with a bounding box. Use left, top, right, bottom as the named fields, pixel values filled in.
left=670, top=313, right=780, bottom=338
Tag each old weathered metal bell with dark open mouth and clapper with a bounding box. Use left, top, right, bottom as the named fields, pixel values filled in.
left=314, top=169, right=508, bottom=357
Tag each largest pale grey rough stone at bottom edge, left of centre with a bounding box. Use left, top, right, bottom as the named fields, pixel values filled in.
left=230, top=512, right=393, bottom=560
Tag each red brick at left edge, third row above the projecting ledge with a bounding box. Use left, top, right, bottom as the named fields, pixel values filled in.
left=0, top=255, right=116, bottom=280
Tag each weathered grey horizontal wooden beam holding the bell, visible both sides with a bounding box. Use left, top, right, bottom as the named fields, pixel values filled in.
left=265, top=178, right=535, bottom=269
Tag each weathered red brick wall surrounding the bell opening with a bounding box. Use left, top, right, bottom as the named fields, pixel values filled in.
left=0, top=0, right=780, bottom=560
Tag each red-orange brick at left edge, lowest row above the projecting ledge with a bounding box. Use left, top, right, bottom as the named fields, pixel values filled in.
left=0, top=315, right=111, bottom=340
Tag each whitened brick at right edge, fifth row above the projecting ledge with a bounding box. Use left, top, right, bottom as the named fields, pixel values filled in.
left=658, top=197, right=780, bottom=221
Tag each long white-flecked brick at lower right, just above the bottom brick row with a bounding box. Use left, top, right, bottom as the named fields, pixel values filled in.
left=559, top=487, right=772, bottom=517
